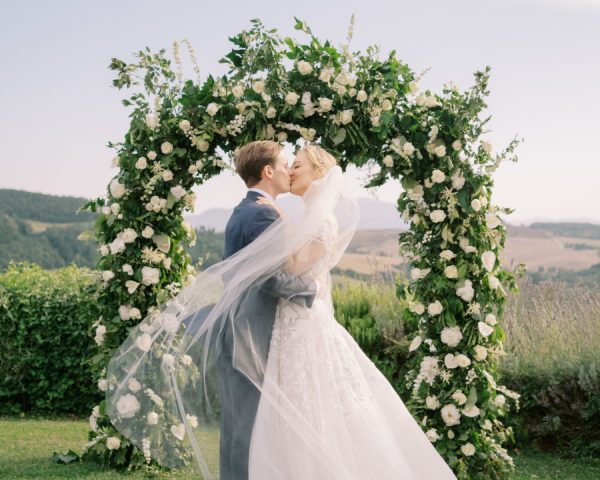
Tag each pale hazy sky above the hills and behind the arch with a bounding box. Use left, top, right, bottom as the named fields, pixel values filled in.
left=0, top=0, right=600, bottom=223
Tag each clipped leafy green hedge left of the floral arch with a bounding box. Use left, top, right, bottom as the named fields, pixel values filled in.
left=0, top=262, right=100, bottom=415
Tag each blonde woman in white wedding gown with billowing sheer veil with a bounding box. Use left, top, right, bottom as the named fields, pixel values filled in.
left=106, top=145, right=456, bottom=480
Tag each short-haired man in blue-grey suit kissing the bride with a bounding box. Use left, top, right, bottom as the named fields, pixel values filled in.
left=218, top=140, right=318, bottom=480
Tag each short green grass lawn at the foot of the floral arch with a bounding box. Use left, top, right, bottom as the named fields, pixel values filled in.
left=0, top=419, right=600, bottom=480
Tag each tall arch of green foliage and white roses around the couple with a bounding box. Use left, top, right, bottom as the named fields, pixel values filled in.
left=83, top=19, right=519, bottom=479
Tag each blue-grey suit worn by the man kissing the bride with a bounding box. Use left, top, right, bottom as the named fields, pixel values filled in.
left=218, top=191, right=317, bottom=480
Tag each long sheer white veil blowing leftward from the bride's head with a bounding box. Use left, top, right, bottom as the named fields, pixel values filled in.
left=106, top=166, right=358, bottom=479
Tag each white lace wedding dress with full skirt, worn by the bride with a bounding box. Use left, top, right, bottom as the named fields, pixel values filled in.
left=249, top=215, right=456, bottom=480
